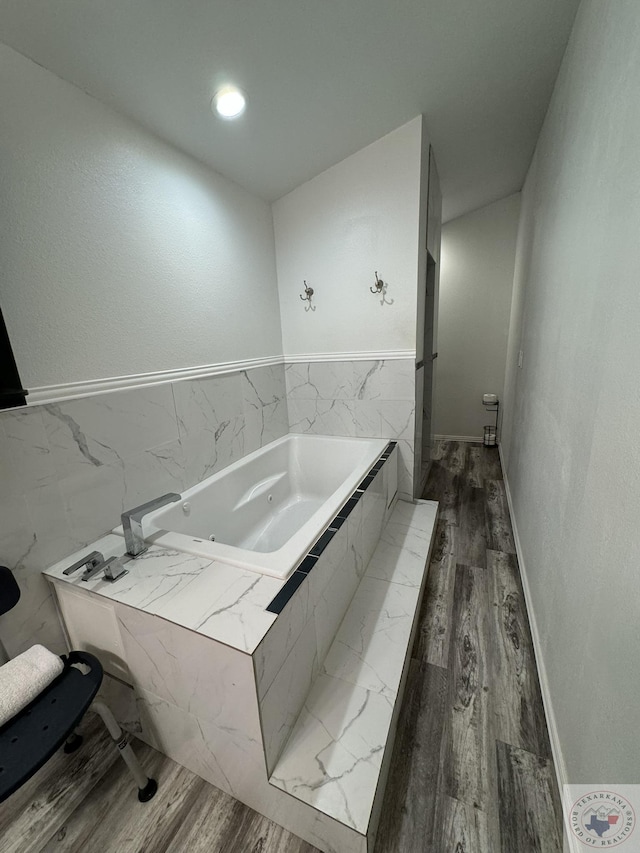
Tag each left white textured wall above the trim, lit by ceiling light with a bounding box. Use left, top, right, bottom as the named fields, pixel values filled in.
left=0, top=45, right=282, bottom=387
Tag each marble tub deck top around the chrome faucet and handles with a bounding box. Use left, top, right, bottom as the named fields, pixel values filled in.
left=44, top=533, right=284, bottom=654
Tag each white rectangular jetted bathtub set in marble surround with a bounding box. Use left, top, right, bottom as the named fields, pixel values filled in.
left=130, top=435, right=387, bottom=578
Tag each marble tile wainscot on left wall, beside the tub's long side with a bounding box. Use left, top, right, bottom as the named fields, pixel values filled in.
left=0, top=365, right=289, bottom=656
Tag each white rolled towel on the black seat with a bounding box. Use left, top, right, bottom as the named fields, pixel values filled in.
left=0, top=645, right=64, bottom=726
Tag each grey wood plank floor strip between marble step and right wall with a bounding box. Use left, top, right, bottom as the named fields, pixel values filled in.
left=376, top=442, right=562, bottom=853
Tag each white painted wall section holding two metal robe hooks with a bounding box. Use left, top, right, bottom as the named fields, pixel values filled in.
left=273, top=116, right=422, bottom=355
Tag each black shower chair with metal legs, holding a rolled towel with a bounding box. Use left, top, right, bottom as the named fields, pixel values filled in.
left=0, top=566, right=158, bottom=803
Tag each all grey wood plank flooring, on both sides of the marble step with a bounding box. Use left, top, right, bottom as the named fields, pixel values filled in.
left=0, top=442, right=562, bottom=853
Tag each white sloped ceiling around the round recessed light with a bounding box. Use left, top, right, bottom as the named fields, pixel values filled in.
left=0, top=0, right=579, bottom=219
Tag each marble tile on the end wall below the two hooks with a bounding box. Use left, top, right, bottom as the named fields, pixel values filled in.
left=285, top=357, right=416, bottom=500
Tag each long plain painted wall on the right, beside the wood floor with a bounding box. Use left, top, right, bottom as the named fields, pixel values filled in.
left=503, top=0, right=640, bottom=786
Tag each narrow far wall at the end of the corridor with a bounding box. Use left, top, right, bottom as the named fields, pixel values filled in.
left=434, top=193, right=520, bottom=437
